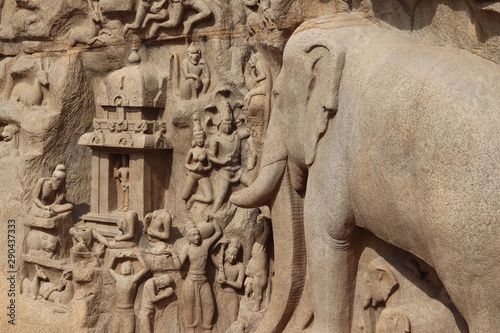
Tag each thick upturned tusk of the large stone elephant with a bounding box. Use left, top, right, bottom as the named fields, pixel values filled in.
left=231, top=158, right=286, bottom=208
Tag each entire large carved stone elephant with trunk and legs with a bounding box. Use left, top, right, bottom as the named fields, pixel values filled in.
left=231, top=14, right=500, bottom=333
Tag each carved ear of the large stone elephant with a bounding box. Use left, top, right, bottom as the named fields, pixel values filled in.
left=303, top=38, right=346, bottom=165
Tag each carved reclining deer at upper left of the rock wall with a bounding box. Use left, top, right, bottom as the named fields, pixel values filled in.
left=10, top=68, right=49, bottom=107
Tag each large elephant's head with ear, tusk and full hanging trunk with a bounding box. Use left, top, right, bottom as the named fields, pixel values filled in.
left=231, top=24, right=346, bottom=332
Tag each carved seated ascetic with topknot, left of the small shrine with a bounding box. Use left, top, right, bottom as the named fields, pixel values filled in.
left=31, top=164, right=73, bottom=217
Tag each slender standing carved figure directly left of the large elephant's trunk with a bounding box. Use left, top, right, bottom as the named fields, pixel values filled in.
left=245, top=214, right=271, bottom=312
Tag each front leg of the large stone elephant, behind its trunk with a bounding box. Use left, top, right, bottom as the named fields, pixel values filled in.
left=304, top=130, right=357, bottom=333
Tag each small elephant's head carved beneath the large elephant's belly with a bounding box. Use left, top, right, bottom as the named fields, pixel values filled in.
left=362, top=257, right=399, bottom=309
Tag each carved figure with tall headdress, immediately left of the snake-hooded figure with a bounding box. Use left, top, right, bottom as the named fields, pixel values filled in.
left=182, top=117, right=214, bottom=209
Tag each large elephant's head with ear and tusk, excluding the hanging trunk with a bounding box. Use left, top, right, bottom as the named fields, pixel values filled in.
left=231, top=38, right=346, bottom=208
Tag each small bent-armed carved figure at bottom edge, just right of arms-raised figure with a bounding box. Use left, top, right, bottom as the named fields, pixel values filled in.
left=137, top=274, right=174, bottom=333
